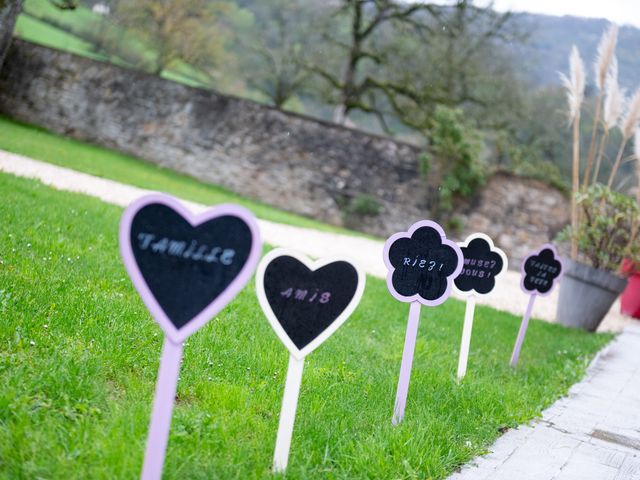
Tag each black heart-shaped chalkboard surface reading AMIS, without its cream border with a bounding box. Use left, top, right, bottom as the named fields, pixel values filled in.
left=257, top=254, right=361, bottom=350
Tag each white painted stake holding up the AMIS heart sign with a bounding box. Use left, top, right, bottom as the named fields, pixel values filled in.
left=273, top=355, right=304, bottom=473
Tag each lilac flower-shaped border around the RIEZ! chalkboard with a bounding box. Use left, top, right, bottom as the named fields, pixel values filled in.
left=382, top=220, right=464, bottom=307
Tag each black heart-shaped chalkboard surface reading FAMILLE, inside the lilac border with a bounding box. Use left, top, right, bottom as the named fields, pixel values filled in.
left=130, top=203, right=252, bottom=329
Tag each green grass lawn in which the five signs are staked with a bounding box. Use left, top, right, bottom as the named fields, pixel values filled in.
left=0, top=171, right=611, bottom=480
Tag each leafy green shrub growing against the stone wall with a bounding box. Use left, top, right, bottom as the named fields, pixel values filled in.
left=430, top=106, right=486, bottom=213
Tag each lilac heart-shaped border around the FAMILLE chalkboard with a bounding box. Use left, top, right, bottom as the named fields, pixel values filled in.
left=118, top=193, right=262, bottom=344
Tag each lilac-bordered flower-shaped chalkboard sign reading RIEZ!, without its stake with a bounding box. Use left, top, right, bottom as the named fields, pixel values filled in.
left=384, top=220, right=463, bottom=306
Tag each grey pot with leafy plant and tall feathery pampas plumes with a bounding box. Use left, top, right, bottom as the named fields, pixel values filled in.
left=556, top=25, right=640, bottom=331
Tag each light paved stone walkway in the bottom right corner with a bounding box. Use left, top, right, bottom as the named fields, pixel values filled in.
left=449, top=324, right=640, bottom=480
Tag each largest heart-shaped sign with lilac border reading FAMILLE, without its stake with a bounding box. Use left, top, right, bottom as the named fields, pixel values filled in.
left=120, top=194, right=261, bottom=343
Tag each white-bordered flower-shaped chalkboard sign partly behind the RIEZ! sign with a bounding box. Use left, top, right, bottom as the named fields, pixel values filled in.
left=454, top=233, right=507, bottom=295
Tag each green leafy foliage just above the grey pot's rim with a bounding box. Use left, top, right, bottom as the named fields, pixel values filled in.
left=561, top=184, right=640, bottom=273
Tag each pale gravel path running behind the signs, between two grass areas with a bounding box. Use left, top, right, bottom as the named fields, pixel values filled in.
left=0, top=150, right=633, bottom=332
